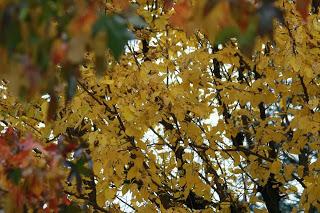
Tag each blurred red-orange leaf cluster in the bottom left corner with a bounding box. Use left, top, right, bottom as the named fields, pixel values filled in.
left=0, top=127, right=69, bottom=211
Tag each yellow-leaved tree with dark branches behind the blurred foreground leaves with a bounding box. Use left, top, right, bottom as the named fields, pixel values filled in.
left=0, top=0, right=320, bottom=212
